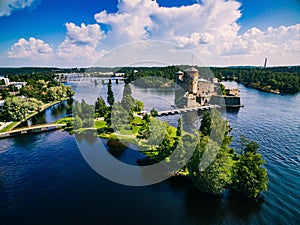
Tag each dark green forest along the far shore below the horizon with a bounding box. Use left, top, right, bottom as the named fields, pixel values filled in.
left=0, top=65, right=300, bottom=94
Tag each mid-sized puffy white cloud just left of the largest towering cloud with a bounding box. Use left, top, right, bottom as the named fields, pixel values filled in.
left=57, top=23, right=104, bottom=63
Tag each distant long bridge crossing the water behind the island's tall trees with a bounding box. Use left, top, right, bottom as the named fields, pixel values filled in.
left=55, top=73, right=127, bottom=84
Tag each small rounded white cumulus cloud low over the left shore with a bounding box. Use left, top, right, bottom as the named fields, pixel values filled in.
left=8, top=37, right=53, bottom=60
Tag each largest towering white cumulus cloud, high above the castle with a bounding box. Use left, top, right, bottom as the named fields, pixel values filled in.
left=95, top=0, right=241, bottom=47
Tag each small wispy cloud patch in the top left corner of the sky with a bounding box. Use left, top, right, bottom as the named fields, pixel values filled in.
left=0, top=0, right=34, bottom=17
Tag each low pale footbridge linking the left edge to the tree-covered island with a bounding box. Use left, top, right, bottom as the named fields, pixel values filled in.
left=0, top=124, right=67, bottom=139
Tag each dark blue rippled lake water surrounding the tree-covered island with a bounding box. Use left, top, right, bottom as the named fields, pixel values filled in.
left=0, top=83, right=300, bottom=225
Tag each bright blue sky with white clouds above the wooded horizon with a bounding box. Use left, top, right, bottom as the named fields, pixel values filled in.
left=0, top=0, right=300, bottom=67
